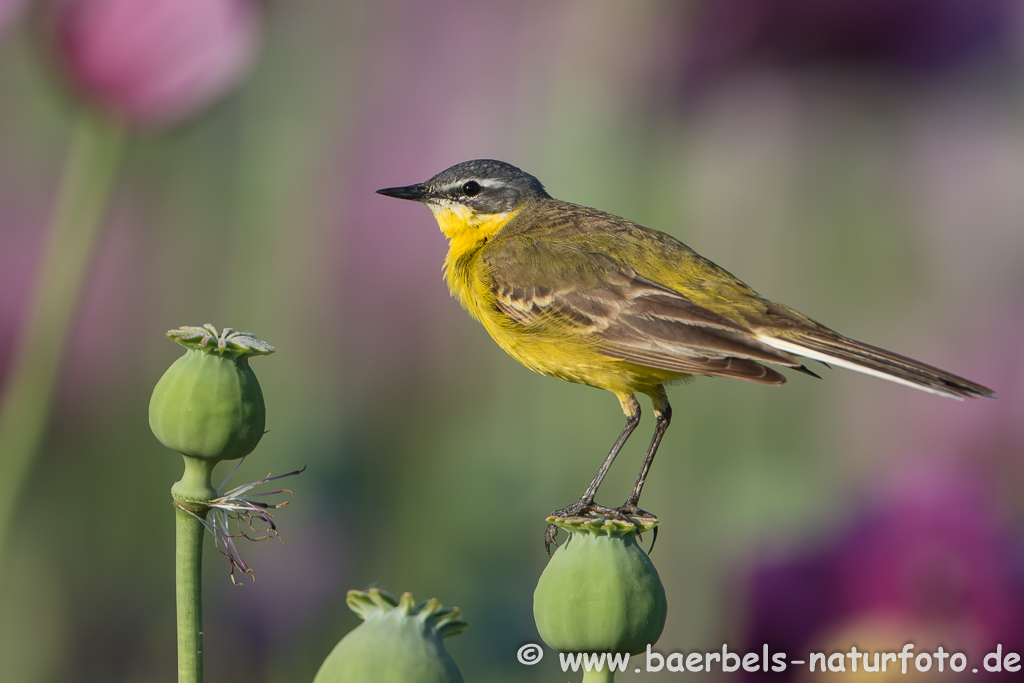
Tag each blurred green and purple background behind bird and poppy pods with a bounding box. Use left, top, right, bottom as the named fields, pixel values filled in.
left=0, top=0, right=1024, bottom=683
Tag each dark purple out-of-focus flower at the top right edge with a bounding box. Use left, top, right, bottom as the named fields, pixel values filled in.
left=685, top=0, right=1015, bottom=89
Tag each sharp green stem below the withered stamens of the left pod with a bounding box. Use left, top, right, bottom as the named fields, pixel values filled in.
left=174, top=501, right=209, bottom=683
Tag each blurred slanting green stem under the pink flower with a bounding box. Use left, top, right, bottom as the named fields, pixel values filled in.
left=0, top=112, right=125, bottom=557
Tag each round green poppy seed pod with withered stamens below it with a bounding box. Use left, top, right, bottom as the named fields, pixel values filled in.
left=150, top=325, right=273, bottom=462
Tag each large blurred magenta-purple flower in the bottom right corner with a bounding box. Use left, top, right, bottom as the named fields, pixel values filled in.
left=744, top=458, right=1024, bottom=680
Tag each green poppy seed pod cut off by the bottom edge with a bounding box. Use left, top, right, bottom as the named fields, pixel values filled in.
left=313, top=588, right=468, bottom=683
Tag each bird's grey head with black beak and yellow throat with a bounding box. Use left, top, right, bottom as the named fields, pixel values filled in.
left=377, top=159, right=550, bottom=239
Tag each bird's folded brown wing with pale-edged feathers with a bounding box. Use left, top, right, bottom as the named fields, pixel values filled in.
left=484, top=239, right=801, bottom=384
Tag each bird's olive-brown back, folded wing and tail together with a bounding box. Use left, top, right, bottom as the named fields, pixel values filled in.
left=480, top=201, right=992, bottom=397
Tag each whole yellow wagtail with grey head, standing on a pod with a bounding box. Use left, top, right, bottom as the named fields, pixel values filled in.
left=377, top=159, right=992, bottom=528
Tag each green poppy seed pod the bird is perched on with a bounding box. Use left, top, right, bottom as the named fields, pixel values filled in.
left=534, top=517, right=668, bottom=654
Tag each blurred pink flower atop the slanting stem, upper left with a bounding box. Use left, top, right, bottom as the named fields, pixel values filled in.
left=52, top=0, right=259, bottom=128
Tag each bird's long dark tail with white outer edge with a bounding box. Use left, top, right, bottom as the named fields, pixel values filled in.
left=758, top=328, right=995, bottom=400
